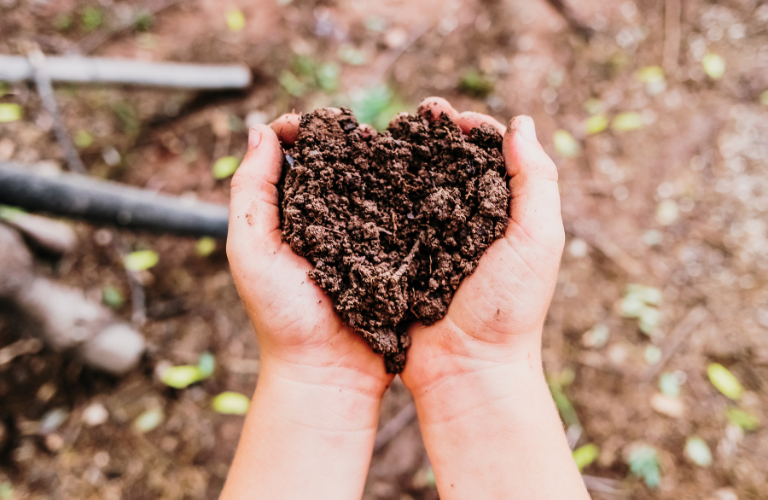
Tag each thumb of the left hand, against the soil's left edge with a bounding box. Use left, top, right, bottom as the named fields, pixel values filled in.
left=227, top=125, right=283, bottom=259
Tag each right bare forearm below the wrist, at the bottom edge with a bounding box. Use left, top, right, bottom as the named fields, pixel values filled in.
left=416, top=348, right=589, bottom=500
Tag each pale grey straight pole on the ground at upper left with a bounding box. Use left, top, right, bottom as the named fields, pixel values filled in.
left=0, top=55, right=251, bottom=89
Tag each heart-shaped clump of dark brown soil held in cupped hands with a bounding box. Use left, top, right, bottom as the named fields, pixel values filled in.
left=281, top=109, right=509, bottom=373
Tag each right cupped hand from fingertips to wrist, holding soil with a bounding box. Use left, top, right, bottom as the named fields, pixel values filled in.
left=402, top=97, right=565, bottom=398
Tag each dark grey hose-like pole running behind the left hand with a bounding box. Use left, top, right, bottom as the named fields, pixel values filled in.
left=0, top=162, right=229, bottom=238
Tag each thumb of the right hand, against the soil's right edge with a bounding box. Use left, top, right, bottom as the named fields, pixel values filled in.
left=502, top=115, right=565, bottom=252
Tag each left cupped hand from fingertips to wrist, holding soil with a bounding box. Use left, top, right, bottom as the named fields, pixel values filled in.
left=227, top=114, right=392, bottom=397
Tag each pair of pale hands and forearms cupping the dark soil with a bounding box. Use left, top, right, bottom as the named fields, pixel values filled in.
left=221, top=98, right=589, bottom=500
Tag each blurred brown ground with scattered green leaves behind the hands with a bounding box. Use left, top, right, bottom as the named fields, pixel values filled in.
left=0, top=0, right=768, bottom=500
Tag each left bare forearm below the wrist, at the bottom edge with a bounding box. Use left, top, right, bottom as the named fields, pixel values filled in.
left=221, top=365, right=380, bottom=500
